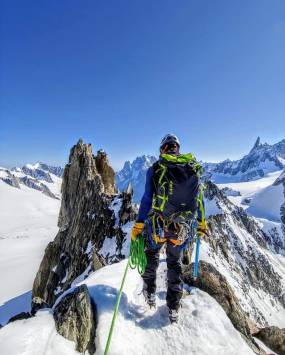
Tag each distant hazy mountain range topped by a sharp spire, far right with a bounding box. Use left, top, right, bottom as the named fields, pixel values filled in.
left=203, top=137, right=285, bottom=183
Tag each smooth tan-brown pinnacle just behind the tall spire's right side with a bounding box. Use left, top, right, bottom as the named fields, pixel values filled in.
left=95, top=149, right=117, bottom=195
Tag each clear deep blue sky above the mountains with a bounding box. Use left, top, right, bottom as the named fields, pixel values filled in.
left=0, top=0, right=285, bottom=169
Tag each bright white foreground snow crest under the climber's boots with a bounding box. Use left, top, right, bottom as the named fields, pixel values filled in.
left=0, top=259, right=254, bottom=355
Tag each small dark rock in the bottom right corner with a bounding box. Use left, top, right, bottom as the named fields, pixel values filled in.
left=254, top=327, right=285, bottom=355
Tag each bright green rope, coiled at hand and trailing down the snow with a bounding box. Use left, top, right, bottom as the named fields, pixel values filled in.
left=104, top=234, right=146, bottom=355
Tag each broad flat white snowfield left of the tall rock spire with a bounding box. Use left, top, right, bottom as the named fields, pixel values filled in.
left=0, top=180, right=60, bottom=308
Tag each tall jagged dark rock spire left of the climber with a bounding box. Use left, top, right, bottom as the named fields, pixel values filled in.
left=32, top=140, right=134, bottom=308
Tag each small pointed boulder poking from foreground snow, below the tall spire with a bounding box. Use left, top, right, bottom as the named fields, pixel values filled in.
left=53, top=285, right=97, bottom=355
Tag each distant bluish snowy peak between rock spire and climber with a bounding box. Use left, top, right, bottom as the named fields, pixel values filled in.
left=116, top=155, right=157, bottom=203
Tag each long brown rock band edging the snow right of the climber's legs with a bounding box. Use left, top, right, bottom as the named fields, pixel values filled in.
left=183, top=261, right=260, bottom=354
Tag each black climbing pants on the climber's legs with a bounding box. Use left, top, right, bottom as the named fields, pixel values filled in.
left=142, top=240, right=183, bottom=310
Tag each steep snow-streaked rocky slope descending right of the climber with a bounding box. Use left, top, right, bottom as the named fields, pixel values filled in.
left=202, top=182, right=285, bottom=326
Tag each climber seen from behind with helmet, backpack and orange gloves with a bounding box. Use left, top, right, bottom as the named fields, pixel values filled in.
left=132, top=134, right=207, bottom=322
